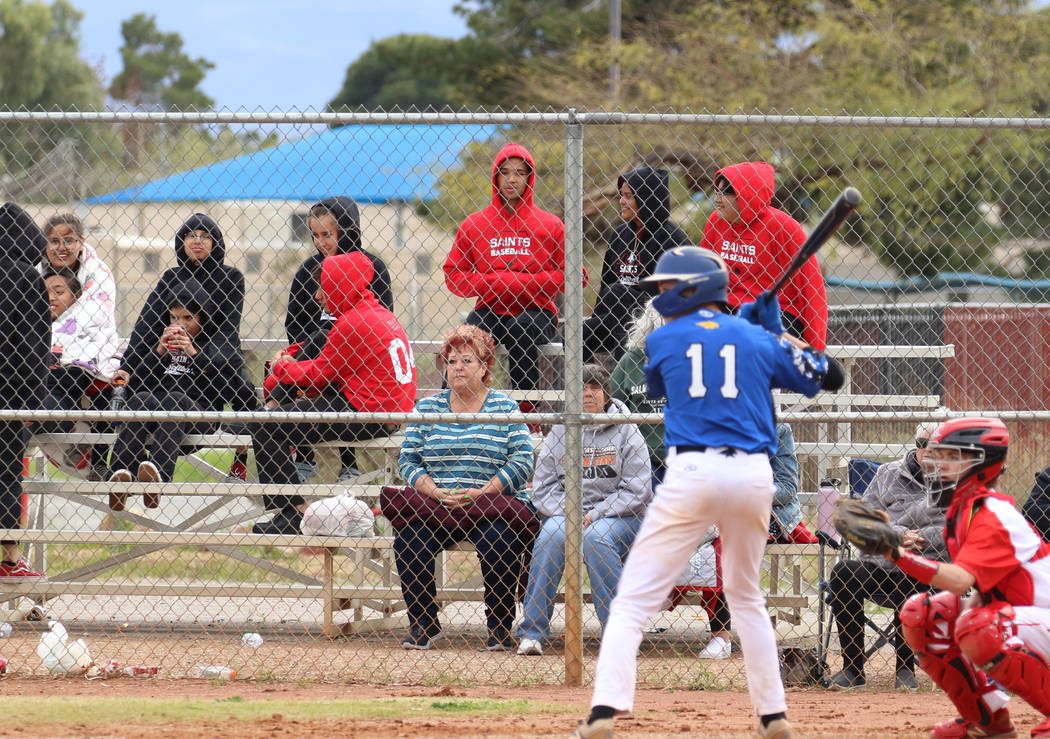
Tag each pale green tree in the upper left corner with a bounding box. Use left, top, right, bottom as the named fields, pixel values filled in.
left=0, top=0, right=105, bottom=197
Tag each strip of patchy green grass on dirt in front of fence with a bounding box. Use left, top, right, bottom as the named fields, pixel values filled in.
left=4, top=696, right=580, bottom=731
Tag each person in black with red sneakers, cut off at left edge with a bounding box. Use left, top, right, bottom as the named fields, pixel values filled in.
left=0, top=203, right=51, bottom=583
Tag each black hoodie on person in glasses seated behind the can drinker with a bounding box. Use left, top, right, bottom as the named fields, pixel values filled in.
left=121, top=213, right=245, bottom=395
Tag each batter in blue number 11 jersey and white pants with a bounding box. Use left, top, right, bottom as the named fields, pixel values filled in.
left=573, top=247, right=843, bottom=739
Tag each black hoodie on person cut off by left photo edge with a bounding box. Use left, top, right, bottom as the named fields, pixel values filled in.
left=0, top=203, right=51, bottom=409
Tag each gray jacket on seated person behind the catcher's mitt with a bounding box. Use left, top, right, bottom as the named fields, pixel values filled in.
left=863, top=449, right=948, bottom=569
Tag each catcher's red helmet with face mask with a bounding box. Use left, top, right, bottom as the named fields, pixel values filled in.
left=922, top=418, right=1010, bottom=506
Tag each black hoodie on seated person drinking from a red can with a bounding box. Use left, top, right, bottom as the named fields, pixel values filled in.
left=129, top=278, right=244, bottom=410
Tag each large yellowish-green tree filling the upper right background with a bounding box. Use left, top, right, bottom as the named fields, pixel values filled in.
left=461, top=0, right=1050, bottom=275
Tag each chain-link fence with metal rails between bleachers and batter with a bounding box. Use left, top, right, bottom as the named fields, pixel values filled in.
left=0, top=112, right=1050, bottom=688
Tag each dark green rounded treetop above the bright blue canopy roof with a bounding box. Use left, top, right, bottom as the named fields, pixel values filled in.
left=328, top=34, right=470, bottom=110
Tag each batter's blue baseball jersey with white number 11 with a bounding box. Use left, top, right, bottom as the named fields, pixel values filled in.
left=646, top=309, right=827, bottom=455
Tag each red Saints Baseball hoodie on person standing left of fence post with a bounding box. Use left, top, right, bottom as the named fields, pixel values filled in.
left=444, top=144, right=587, bottom=316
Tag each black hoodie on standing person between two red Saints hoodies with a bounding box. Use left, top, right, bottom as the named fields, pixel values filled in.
left=594, top=167, right=691, bottom=322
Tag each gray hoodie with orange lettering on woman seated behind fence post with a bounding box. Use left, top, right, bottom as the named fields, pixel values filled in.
left=532, top=398, right=653, bottom=520
